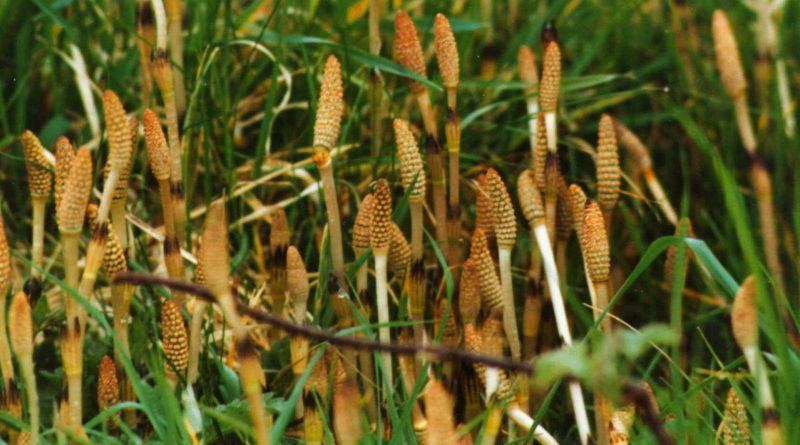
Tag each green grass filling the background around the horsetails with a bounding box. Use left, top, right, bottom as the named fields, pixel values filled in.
left=0, top=0, right=800, bottom=444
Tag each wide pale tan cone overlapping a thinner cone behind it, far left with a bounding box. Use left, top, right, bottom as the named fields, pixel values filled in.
left=56, top=147, right=92, bottom=233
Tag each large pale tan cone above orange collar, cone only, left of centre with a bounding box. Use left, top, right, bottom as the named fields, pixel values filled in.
left=314, top=54, right=344, bottom=154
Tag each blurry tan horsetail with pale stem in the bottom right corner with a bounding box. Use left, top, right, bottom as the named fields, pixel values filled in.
left=731, top=275, right=784, bottom=445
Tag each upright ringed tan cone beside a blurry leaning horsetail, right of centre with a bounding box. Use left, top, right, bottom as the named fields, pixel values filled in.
left=596, top=114, right=620, bottom=212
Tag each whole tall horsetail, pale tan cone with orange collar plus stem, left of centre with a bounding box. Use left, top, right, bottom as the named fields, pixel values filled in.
left=313, top=55, right=347, bottom=289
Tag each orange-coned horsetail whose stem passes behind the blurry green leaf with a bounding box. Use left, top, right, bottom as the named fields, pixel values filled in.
left=580, top=199, right=611, bottom=441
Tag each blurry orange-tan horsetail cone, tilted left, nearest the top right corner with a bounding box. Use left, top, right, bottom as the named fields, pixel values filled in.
left=711, top=9, right=747, bottom=99
